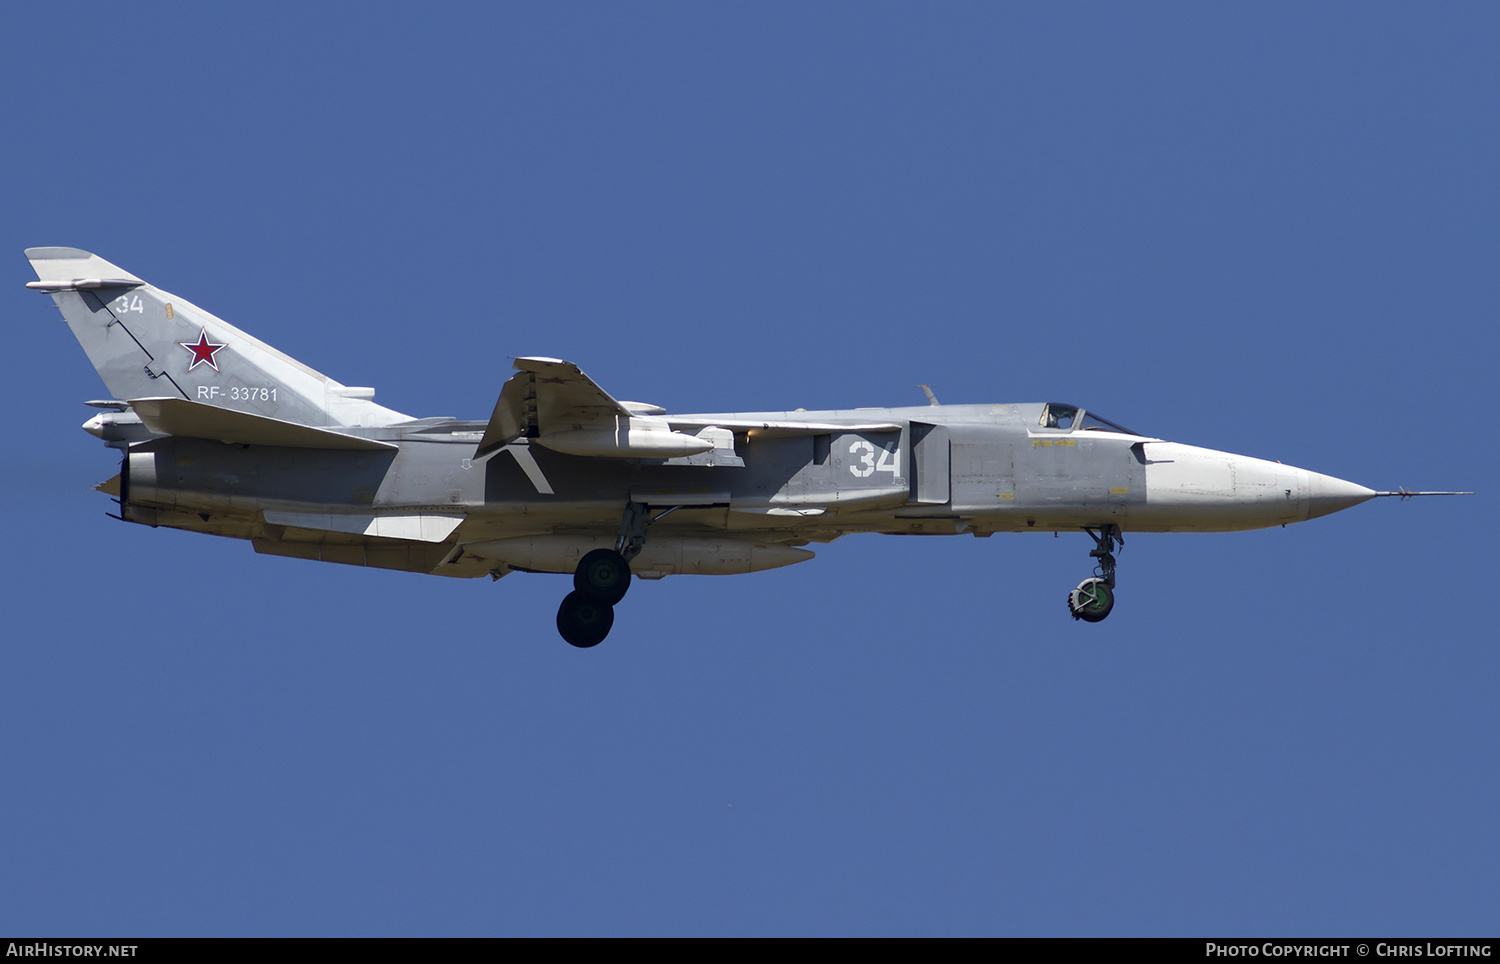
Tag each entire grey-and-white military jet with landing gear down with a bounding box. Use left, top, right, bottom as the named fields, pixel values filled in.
left=26, top=247, right=1457, bottom=646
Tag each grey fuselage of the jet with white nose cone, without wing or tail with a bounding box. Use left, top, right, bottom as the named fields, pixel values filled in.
left=96, top=403, right=1376, bottom=574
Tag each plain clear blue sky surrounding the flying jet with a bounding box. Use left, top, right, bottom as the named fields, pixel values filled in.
left=0, top=3, right=1500, bottom=937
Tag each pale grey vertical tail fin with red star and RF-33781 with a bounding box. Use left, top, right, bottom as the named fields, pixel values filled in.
left=26, top=247, right=408, bottom=426
